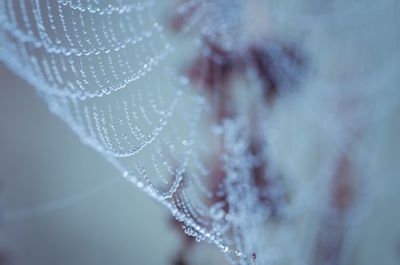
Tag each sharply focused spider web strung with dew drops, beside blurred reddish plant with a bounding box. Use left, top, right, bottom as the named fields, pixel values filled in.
left=0, top=0, right=256, bottom=260
